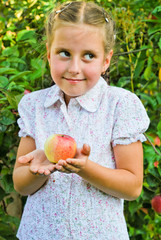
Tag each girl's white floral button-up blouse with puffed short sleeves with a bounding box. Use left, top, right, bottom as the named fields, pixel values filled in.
left=17, top=78, right=149, bottom=240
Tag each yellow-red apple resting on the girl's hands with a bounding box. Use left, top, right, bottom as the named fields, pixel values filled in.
left=44, top=134, right=77, bottom=163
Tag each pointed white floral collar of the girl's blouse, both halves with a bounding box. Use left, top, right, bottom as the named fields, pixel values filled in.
left=44, top=77, right=108, bottom=112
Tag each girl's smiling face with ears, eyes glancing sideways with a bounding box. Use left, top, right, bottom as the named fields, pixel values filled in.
left=47, top=24, right=113, bottom=104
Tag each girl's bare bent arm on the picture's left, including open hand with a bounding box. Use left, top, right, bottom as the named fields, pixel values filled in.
left=13, top=137, right=53, bottom=196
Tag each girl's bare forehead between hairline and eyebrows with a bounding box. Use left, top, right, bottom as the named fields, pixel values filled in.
left=52, top=24, right=104, bottom=50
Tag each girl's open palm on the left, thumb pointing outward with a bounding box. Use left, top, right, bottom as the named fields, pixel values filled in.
left=18, top=149, right=55, bottom=176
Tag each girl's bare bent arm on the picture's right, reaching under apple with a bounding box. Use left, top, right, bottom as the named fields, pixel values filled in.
left=57, top=141, right=143, bottom=200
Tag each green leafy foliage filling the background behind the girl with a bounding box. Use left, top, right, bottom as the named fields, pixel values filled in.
left=0, top=0, right=161, bottom=240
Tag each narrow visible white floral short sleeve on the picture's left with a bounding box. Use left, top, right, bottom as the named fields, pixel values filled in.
left=17, top=93, right=35, bottom=138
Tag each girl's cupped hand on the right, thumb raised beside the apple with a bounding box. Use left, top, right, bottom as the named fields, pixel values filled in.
left=55, top=144, right=90, bottom=173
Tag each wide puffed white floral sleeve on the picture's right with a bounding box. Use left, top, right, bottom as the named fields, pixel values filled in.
left=112, top=92, right=150, bottom=146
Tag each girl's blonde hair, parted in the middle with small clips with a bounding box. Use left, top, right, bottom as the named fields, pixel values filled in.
left=46, top=1, right=115, bottom=53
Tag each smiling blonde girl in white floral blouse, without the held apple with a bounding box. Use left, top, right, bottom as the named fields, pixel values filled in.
left=13, top=2, right=149, bottom=240
